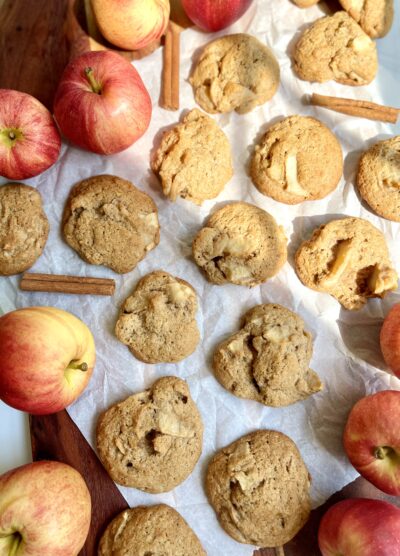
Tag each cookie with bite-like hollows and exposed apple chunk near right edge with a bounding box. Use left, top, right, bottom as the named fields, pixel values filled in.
left=295, top=217, right=398, bottom=310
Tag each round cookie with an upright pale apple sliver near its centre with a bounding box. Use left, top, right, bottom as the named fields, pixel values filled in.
left=250, top=116, right=343, bottom=205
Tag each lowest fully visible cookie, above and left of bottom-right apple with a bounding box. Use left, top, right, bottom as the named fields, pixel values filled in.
left=206, top=430, right=310, bottom=547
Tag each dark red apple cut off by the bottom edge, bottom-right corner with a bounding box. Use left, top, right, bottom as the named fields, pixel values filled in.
left=318, top=498, right=400, bottom=556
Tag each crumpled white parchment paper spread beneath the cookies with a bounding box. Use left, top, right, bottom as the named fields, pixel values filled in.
left=0, top=0, right=400, bottom=556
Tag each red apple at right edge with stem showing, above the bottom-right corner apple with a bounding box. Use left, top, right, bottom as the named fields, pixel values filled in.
left=343, top=390, right=400, bottom=496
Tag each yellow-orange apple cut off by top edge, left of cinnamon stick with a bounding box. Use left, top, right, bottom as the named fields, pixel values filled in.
left=92, top=0, right=170, bottom=50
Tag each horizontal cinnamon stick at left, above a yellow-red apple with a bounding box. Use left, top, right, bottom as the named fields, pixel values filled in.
left=20, top=272, right=115, bottom=295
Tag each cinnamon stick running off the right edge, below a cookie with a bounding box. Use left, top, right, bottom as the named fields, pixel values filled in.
left=310, top=93, right=400, bottom=124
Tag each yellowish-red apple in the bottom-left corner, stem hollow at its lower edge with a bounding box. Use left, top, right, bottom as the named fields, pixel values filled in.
left=0, top=461, right=91, bottom=556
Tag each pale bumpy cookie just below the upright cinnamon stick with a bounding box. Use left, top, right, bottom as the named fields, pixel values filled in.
left=151, top=109, right=233, bottom=205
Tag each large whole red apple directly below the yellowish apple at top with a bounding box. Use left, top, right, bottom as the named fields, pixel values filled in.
left=54, top=51, right=151, bottom=154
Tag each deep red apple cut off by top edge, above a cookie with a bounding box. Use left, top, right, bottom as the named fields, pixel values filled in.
left=182, top=0, right=252, bottom=32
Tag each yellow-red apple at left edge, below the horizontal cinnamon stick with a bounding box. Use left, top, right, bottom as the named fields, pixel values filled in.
left=0, top=307, right=96, bottom=415
